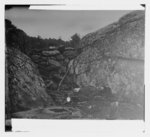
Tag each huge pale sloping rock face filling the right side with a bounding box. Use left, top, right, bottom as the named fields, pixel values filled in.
left=69, top=11, right=145, bottom=112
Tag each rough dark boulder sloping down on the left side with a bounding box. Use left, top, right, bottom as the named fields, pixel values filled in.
left=6, top=48, right=53, bottom=113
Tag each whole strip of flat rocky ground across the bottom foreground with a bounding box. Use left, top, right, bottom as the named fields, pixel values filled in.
left=12, top=102, right=144, bottom=120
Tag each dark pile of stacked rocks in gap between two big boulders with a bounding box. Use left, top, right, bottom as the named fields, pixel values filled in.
left=30, top=45, right=78, bottom=94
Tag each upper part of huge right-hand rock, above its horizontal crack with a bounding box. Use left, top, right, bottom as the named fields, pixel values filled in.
left=81, top=11, right=145, bottom=60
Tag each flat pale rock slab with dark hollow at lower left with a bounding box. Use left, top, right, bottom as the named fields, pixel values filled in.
left=12, top=106, right=82, bottom=119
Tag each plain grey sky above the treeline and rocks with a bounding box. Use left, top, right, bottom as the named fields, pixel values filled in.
left=5, top=8, right=131, bottom=41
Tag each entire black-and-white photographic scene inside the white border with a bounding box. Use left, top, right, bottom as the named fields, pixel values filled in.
left=5, top=5, right=145, bottom=126
